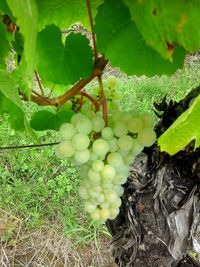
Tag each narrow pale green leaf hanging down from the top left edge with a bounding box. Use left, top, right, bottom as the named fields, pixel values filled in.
left=7, top=0, right=38, bottom=89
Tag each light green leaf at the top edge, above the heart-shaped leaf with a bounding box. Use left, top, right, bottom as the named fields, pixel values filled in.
left=37, top=0, right=103, bottom=30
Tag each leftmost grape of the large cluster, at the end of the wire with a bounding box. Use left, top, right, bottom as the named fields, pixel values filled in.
left=55, top=140, right=75, bottom=159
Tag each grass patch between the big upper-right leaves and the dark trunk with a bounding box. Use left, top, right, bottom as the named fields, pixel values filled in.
left=119, top=56, right=200, bottom=111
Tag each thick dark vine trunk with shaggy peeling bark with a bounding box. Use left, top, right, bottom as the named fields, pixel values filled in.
left=107, top=87, right=200, bottom=267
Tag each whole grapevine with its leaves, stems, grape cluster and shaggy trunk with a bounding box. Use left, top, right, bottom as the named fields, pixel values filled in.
left=0, top=0, right=200, bottom=267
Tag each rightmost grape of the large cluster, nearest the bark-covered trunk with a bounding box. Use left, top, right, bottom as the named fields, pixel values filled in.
left=138, top=128, right=156, bottom=147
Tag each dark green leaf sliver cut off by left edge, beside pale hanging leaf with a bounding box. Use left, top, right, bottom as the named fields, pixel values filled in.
left=0, top=22, right=10, bottom=64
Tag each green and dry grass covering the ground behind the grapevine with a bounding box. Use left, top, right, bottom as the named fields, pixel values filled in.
left=0, top=56, right=200, bottom=266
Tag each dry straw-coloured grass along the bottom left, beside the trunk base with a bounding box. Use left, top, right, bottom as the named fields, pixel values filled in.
left=0, top=210, right=115, bottom=267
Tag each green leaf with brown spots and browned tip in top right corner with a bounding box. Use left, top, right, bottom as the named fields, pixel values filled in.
left=124, top=0, right=200, bottom=58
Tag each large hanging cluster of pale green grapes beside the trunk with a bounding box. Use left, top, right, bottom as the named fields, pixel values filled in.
left=56, top=110, right=156, bottom=221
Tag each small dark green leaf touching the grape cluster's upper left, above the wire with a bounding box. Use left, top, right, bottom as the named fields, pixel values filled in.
left=30, top=110, right=73, bottom=131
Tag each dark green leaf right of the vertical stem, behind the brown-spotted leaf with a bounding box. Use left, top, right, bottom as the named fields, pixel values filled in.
left=95, top=0, right=186, bottom=76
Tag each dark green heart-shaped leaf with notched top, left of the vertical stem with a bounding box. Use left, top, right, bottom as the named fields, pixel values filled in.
left=37, top=25, right=93, bottom=85
